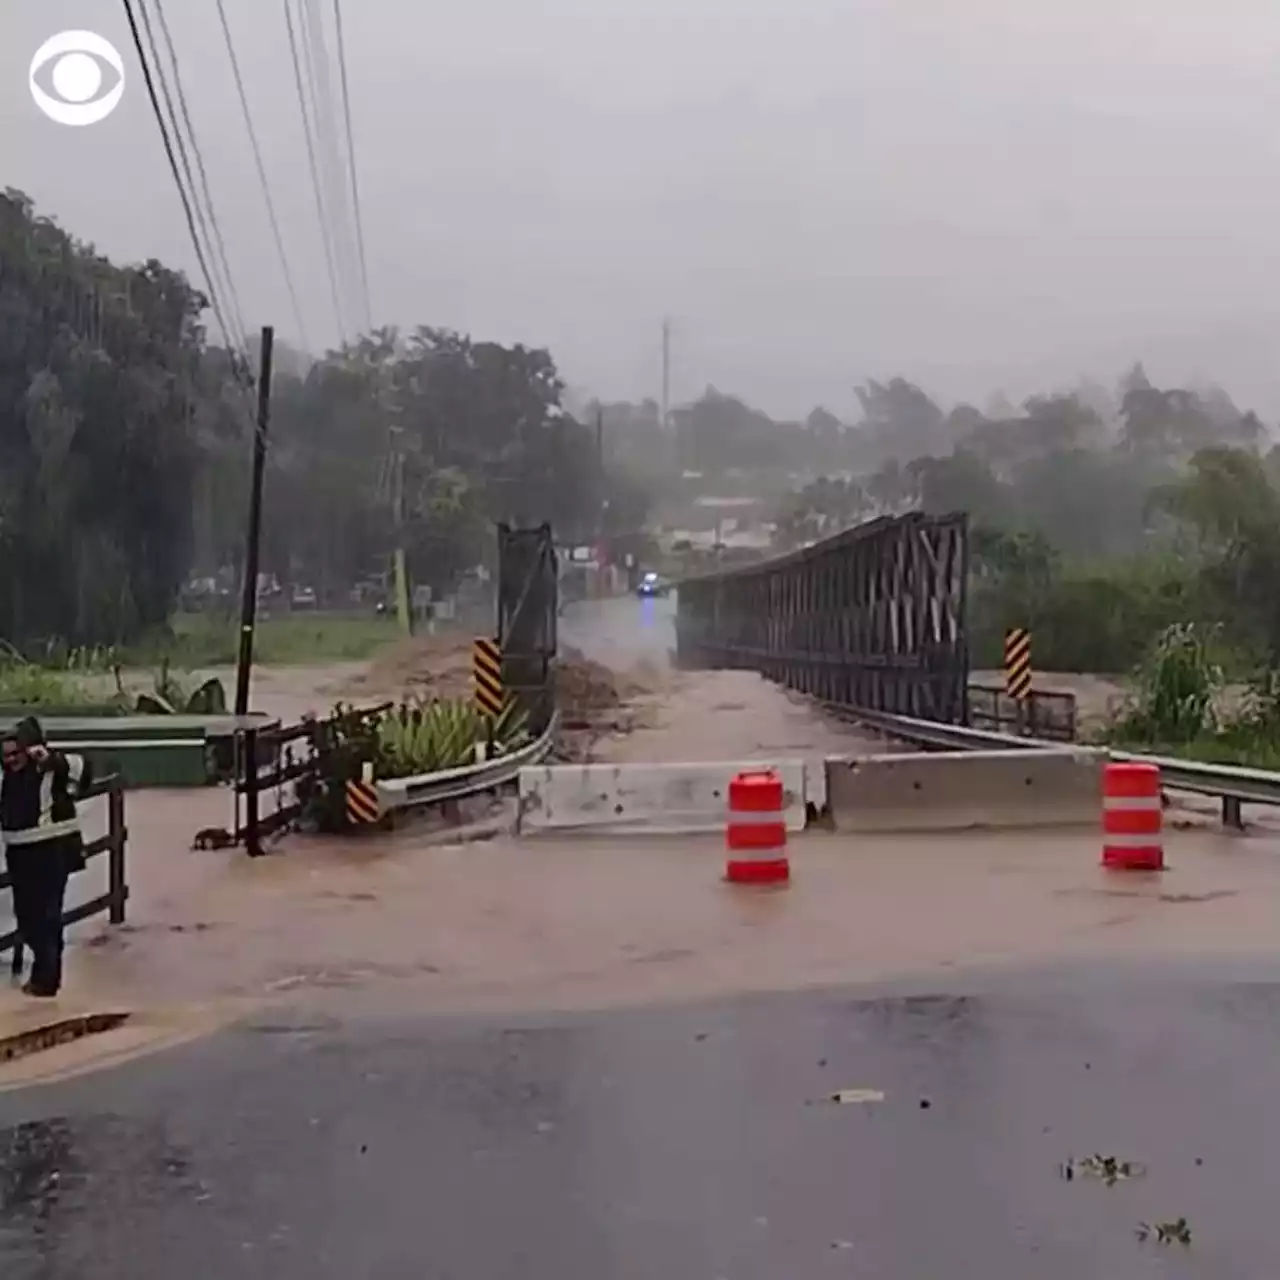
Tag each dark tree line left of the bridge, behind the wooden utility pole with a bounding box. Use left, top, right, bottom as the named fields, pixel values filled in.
left=0, top=189, right=645, bottom=649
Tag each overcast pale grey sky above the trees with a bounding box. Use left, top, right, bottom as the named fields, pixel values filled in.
left=0, top=0, right=1280, bottom=416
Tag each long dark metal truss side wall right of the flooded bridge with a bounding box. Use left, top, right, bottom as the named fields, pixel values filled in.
left=676, top=512, right=969, bottom=724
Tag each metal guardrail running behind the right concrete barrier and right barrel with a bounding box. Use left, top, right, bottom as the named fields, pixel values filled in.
left=822, top=703, right=1280, bottom=829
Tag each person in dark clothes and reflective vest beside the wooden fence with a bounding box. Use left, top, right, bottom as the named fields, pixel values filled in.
left=0, top=717, right=88, bottom=998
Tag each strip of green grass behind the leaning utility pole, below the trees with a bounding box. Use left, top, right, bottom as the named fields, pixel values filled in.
left=122, top=613, right=401, bottom=669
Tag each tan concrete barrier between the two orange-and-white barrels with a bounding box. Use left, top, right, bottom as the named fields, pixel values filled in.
left=827, top=748, right=1107, bottom=832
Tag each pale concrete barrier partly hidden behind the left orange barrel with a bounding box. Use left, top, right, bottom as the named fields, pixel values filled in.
left=520, top=760, right=803, bottom=835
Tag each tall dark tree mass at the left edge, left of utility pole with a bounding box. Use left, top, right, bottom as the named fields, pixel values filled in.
left=0, top=189, right=206, bottom=643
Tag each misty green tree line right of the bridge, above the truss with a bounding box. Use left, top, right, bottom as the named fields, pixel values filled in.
left=776, top=365, right=1280, bottom=672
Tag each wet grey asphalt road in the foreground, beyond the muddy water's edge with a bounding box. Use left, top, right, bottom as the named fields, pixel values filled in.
left=0, top=973, right=1280, bottom=1280
